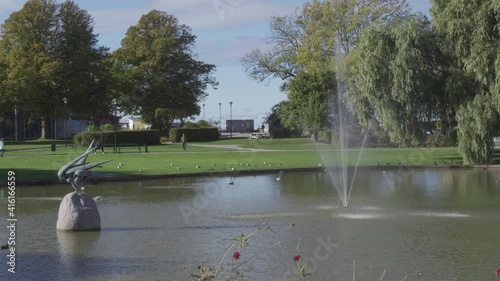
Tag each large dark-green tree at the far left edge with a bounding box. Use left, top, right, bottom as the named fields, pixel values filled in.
left=0, top=0, right=111, bottom=138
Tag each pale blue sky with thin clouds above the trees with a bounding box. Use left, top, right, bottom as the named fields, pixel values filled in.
left=0, top=0, right=430, bottom=128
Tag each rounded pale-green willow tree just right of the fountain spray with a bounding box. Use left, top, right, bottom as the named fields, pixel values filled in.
left=351, top=16, right=453, bottom=145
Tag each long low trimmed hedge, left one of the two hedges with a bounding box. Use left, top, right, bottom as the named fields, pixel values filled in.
left=73, top=130, right=160, bottom=146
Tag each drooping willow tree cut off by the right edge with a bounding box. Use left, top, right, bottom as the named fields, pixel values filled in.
left=431, top=0, right=500, bottom=164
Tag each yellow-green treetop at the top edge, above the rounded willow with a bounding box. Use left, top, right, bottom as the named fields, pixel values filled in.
left=297, top=0, right=409, bottom=69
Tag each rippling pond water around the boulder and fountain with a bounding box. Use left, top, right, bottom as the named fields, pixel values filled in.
left=0, top=168, right=500, bottom=281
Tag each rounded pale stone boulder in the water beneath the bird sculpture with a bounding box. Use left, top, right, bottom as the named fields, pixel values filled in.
left=57, top=191, right=101, bottom=231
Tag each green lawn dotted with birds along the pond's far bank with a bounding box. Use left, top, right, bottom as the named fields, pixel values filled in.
left=0, top=138, right=492, bottom=185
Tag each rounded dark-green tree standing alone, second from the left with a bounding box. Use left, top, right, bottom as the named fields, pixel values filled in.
left=113, top=10, right=218, bottom=129
